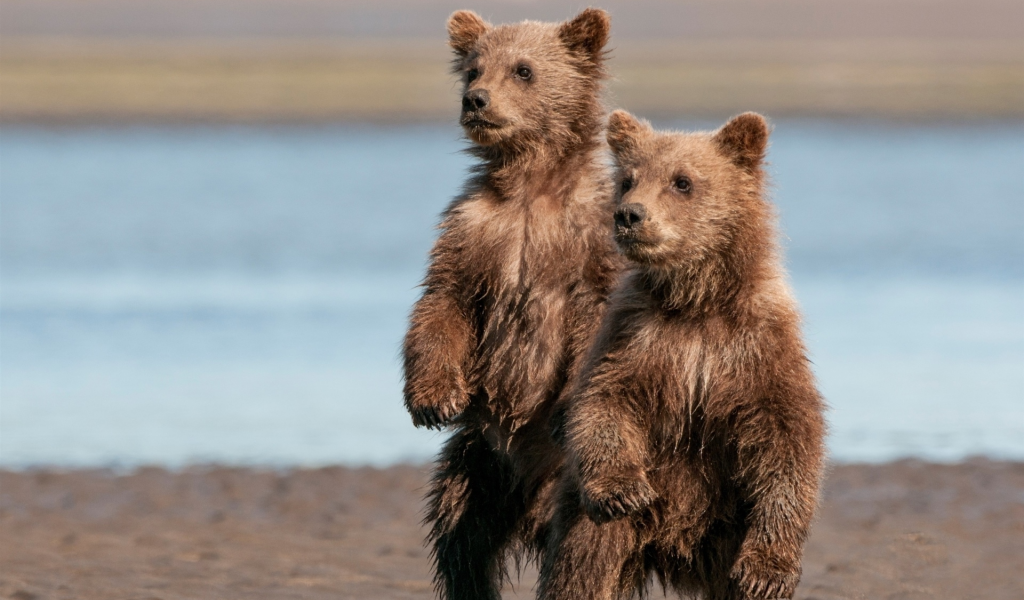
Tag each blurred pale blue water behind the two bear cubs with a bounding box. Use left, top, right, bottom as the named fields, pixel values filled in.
left=0, top=121, right=1024, bottom=466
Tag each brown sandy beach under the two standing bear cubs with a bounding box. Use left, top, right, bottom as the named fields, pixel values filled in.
left=0, top=459, right=1024, bottom=600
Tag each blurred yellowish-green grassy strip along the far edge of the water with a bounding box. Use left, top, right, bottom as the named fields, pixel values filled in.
left=0, top=39, right=1024, bottom=123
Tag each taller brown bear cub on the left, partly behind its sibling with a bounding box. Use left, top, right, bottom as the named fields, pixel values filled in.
left=404, top=10, right=625, bottom=600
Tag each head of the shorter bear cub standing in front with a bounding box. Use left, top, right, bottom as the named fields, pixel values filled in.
left=607, top=111, right=769, bottom=269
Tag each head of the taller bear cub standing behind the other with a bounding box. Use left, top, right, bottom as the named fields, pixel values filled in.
left=447, top=8, right=610, bottom=149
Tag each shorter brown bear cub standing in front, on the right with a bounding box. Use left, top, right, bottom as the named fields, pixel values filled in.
left=541, top=112, right=825, bottom=600
